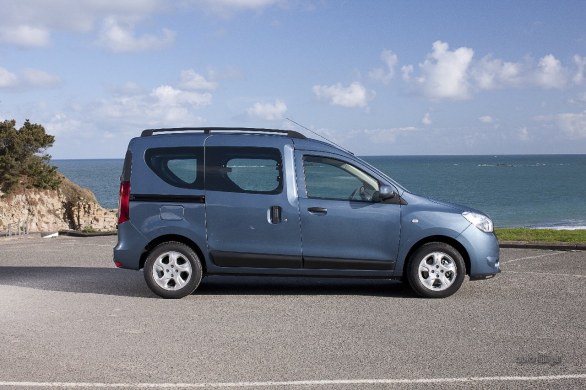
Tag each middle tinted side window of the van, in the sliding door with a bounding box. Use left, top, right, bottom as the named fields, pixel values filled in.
left=206, top=146, right=283, bottom=194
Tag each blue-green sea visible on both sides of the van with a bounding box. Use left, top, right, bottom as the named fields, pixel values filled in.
left=52, top=154, right=586, bottom=229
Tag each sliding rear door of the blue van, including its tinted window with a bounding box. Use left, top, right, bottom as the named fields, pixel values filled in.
left=205, top=135, right=301, bottom=268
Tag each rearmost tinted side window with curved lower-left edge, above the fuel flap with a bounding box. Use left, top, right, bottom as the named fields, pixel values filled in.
left=145, top=148, right=203, bottom=189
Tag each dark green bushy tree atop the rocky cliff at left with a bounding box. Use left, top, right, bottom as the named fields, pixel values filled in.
left=0, top=119, right=60, bottom=194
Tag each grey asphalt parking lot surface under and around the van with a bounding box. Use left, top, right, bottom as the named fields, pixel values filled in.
left=0, top=236, right=586, bottom=389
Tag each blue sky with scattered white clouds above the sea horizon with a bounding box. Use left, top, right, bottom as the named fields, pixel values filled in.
left=0, top=0, right=586, bottom=159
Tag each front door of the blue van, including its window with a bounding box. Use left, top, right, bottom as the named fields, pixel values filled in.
left=296, top=151, right=401, bottom=270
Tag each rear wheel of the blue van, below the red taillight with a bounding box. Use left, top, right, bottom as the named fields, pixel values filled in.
left=144, top=241, right=203, bottom=299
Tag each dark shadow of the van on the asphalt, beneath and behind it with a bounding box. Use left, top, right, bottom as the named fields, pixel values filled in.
left=0, top=266, right=416, bottom=299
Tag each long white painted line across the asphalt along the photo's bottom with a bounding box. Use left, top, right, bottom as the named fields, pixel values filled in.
left=0, top=374, right=586, bottom=389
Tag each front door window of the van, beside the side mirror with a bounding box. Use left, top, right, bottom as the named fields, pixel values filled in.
left=303, top=156, right=379, bottom=202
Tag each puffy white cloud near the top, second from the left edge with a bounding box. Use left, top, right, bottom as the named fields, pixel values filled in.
left=97, top=17, right=175, bottom=53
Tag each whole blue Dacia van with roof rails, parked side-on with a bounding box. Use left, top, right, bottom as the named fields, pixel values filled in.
left=114, top=128, right=500, bottom=298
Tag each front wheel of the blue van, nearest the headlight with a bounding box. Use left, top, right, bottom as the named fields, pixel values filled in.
left=407, top=242, right=466, bottom=298
